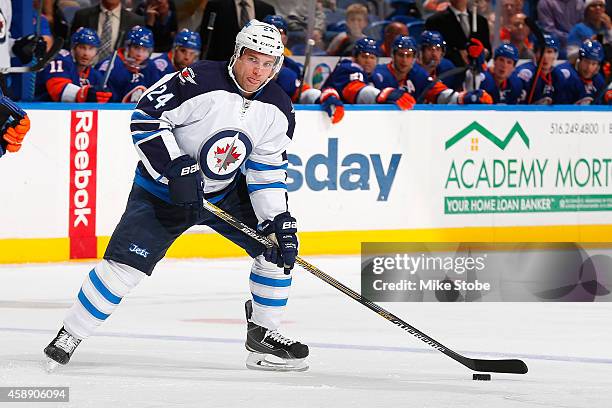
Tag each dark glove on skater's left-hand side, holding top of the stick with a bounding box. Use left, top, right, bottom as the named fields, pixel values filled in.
left=163, top=155, right=204, bottom=224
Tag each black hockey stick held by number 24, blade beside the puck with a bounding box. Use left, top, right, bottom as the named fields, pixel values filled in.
left=204, top=200, right=527, bottom=374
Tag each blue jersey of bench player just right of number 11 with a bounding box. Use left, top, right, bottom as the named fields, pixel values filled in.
left=98, top=48, right=163, bottom=103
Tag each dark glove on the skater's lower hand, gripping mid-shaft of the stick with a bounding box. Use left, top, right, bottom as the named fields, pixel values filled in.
left=257, top=211, right=298, bottom=275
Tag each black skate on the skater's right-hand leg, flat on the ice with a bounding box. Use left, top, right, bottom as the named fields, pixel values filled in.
left=244, top=300, right=308, bottom=371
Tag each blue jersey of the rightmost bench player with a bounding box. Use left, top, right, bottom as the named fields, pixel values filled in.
left=553, top=62, right=606, bottom=105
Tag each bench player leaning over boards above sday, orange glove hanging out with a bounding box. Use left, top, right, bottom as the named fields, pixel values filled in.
left=321, top=38, right=416, bottom=110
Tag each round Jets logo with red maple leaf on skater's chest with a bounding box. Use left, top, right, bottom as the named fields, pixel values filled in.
left=200, top=129, right=253, bottom=180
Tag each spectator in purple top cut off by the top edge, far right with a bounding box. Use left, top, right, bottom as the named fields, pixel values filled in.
left=538, top=0, right=584, bottom=51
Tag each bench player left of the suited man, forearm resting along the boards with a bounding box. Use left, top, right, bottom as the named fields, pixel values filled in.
left=372, top=35, right=491, bottom=104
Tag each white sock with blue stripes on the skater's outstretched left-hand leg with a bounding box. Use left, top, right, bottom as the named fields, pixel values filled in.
left=64, top=259, right=146, bottom=339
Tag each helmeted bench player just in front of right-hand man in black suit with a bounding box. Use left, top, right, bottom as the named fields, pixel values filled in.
left=417, top=30, right=462, bottom=91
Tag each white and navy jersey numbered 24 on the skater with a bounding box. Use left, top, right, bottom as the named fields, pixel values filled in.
left=131, top=61, right=295, bottom=222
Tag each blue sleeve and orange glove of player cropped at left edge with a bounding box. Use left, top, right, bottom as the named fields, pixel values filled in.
left=0, top=92, right=30, bottom=157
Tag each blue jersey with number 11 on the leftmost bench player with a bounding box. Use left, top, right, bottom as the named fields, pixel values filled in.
left=35, top=50, right=104, bottom=102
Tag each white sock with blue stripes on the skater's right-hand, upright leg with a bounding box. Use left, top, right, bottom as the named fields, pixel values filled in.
left=249, top=255, right=291, bottom=330
